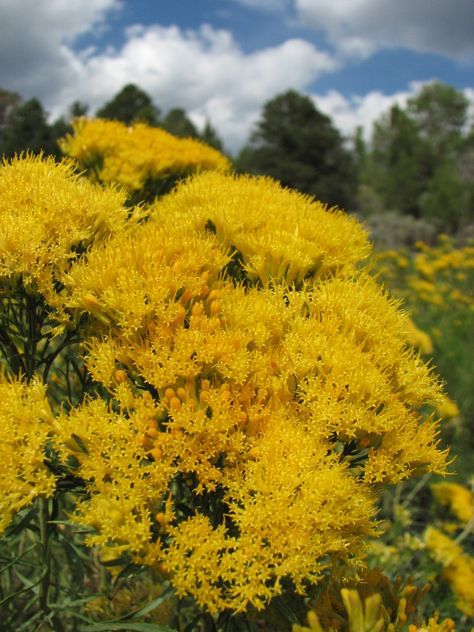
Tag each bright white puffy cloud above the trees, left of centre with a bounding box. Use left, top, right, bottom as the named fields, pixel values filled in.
left=75, top=25, right=336, bottom=150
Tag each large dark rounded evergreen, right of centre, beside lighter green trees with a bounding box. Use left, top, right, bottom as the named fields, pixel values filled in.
left=237, top=90, right=355, bottom=208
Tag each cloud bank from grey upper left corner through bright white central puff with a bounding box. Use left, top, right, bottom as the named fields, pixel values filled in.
left=0, top=0, right=337, bottom=151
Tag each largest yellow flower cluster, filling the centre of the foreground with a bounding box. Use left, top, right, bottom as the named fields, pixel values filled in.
left=54, top=173, right=446, bottom=612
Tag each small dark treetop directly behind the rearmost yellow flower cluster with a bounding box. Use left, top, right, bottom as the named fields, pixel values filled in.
left=97, top=83, right=160, bottom=125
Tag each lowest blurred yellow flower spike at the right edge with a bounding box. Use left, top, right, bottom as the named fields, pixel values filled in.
left=425, top=527, right=474, bottom=617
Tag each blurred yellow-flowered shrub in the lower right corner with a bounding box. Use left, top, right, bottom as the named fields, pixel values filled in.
left=359, top=476, right=474, bottom=631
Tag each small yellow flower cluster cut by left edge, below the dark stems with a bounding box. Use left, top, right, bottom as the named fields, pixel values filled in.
left=0, top=376, right=56, bottom=534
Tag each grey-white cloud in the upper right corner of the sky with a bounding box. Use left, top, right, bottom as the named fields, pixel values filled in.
left=294, top=0, right=474, bottom=60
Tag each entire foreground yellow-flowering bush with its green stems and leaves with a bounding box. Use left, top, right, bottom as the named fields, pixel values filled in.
left=0, top=127, right=454, bottom=631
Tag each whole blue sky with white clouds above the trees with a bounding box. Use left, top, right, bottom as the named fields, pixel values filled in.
left=0, top=0, right=474, bottom=153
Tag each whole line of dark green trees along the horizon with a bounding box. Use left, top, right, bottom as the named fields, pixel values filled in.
left=0, top=82, right=474, bottom=236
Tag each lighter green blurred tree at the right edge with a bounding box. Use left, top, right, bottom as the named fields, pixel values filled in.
left=355, top=82, right=474, bottom=233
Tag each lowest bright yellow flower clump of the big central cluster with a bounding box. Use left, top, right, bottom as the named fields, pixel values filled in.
left=161, top=420, right=373, bottom=611
